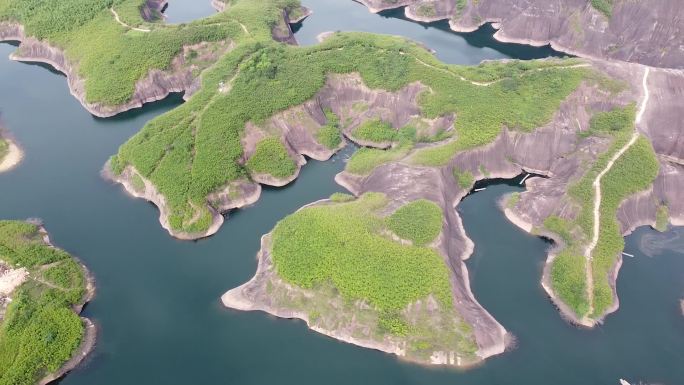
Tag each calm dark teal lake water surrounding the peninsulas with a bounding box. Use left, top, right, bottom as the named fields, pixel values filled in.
left=0, top=0, right=684, bottom=385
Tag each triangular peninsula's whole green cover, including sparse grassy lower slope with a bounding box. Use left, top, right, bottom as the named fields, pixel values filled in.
left=269, top=193, right=477, bottom=359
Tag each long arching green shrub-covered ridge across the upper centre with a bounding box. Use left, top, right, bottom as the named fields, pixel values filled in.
left=111, top=21, right=588, bottom=232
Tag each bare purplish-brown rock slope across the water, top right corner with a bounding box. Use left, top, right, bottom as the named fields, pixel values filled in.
left=360, top=0, right=684, bottom=68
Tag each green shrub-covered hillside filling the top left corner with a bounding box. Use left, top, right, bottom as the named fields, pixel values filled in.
left=0, top=0, right=296, bottom=106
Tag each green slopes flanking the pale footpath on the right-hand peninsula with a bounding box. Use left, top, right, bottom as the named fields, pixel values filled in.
left=544, top=105, right=659, bottom=319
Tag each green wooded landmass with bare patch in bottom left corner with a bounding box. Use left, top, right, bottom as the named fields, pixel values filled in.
left=0, top=220, right=96, bottom=385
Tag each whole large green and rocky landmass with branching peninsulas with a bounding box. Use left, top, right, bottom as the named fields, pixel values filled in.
left=0, top=0, right=680, bottom=365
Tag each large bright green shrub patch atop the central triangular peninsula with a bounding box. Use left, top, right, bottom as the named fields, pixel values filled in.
left=272, top=193, right=452, bottom=311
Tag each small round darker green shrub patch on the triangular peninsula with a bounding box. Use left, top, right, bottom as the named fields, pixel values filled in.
left=387, top=199, right=444, bottom=246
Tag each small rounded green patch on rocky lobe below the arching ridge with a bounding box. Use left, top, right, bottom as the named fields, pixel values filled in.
left=247, top=137, right=297, bottom=179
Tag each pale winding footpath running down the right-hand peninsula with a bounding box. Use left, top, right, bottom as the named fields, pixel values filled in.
left=585, top=67, right=651, bottom=314
